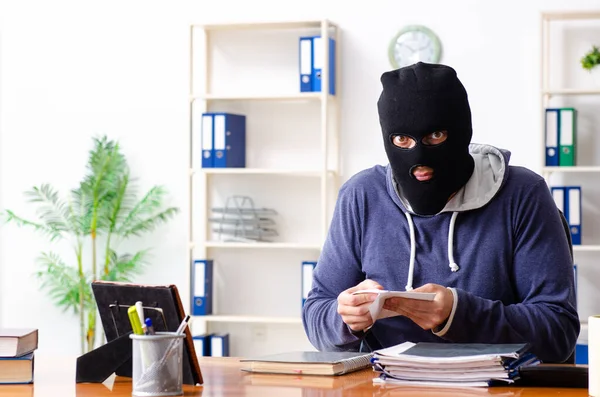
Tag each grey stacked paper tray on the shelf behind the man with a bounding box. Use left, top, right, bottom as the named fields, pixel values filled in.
left=209, top=196, right=278, bottom=242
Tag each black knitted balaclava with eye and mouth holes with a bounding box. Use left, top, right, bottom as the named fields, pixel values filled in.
left=377, top=62, right=474, bottom=215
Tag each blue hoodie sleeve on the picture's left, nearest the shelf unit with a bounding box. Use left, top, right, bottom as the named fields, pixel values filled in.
left=302, top=183, right=365, bottom=351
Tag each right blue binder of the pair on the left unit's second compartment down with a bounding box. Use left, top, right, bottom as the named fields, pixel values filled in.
left=213, top=113, right=246, bottom=168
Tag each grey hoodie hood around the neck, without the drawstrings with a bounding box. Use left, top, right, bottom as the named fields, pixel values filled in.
left=386, top=143, right=510, bottom=216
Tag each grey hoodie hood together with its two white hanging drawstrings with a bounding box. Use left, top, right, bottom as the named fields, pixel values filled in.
left=386, top=143, right=510, bottom=291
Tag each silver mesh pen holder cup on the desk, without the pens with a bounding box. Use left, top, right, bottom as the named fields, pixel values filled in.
left=129, top=332, right=185, bottom=396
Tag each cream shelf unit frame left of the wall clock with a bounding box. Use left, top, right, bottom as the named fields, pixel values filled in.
left=188, top=20, right=342, bottom=352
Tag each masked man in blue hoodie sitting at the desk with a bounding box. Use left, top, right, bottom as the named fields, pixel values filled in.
left=303, top=63, right=580, bottom=362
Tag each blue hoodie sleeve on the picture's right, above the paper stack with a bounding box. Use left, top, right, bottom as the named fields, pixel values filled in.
left=443, top=180, right=580, bottom=362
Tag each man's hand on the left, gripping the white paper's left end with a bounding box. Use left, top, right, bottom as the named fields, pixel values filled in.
left=338, top=280, right=383, bottom=331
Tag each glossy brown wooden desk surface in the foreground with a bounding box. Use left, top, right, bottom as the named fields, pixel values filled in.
left=0, top=356, right=588, bottom=397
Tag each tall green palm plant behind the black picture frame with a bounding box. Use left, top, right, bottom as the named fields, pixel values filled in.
left=3, top=137, right=179, bottom=353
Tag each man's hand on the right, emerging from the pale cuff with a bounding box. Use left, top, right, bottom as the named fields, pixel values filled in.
left=383, top=284, right=454, bottom=330
